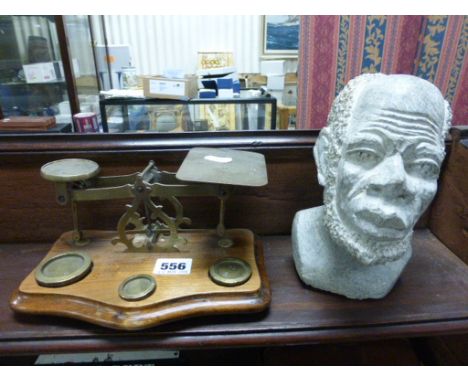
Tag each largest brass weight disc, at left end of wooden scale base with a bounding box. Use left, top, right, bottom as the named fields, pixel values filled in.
left=36, top=252, right=93, bottom=287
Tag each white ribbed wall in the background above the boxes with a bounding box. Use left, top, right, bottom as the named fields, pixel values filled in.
left=92, top=15, right=297, bottom=74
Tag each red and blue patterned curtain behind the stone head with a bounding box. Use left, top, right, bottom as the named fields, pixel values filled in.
left=297, top=16, right=468, bottom=129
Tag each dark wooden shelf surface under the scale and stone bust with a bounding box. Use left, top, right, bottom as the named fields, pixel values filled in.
left=0, top=229, right=468, bottom=355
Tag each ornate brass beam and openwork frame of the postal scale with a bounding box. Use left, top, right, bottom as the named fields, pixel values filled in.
left=47, top=159, right=232, bottom=251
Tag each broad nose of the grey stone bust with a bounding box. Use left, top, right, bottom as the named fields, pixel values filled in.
left=367, top=153, right=413, bottom=202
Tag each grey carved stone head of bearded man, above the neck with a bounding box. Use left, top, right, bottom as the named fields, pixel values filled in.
left=314, top=74, right=452, bottom=264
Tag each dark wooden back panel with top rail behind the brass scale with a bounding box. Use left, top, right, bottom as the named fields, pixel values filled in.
left=0, top=131, right=442, bottom=242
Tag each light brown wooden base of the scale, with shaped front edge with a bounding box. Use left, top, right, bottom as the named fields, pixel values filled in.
left=10, top=229, right=270, bottom=330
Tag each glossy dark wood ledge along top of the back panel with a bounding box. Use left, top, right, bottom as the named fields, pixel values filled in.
left=0, top=130, right=318, bottom=159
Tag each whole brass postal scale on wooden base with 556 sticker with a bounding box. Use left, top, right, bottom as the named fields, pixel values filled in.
left=10, top=148, right=270, bottom=330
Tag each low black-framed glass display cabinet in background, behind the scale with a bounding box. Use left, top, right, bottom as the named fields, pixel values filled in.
left=100, top=96, right=277, bottom=133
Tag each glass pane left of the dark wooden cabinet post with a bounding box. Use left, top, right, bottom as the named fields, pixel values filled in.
left=0, top=16, right=71, bottom=124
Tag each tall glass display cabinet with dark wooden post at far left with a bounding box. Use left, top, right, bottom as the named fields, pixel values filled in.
left=0, top=15, right=99, bottom=131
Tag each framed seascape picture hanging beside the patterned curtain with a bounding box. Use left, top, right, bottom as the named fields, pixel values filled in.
left=262, top=15, right=300, bottom=57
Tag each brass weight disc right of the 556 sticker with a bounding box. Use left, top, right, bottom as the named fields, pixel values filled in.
left=209, top=257, right=252, bottom=286
